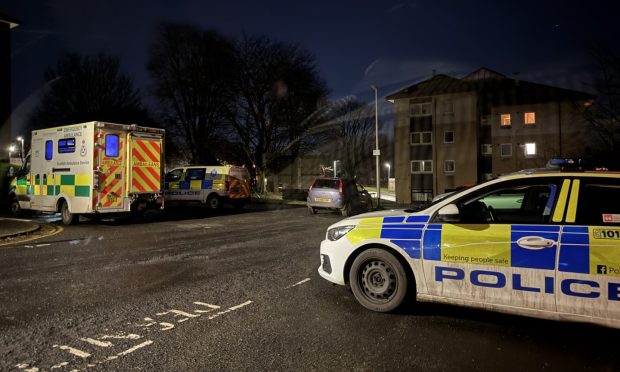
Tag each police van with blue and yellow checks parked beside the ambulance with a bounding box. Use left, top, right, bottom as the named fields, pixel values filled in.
left=164, top=165, right=252, bottom=209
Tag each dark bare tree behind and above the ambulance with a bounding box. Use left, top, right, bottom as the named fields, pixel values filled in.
left=30, top=54, right=150, bottom=128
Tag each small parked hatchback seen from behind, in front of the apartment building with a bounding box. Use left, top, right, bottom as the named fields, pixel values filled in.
left=307, top=177, right=372, bottom=217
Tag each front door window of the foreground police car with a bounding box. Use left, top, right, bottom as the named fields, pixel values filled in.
left=456, top=180, right=558, bottom=224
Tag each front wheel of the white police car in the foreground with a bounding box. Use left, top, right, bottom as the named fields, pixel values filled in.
left=349, top=248, right=409, bottom=312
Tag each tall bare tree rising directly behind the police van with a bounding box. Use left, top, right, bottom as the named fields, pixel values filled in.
left=147, top=24, right=235, bottom=164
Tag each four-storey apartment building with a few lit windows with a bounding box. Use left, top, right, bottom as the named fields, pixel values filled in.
left=387, top=68, right=594, bottom=205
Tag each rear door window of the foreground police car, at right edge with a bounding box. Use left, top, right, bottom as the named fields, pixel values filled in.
left=573, top=179, right=620, bottom=225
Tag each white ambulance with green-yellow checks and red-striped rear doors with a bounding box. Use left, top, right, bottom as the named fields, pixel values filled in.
left=9, top=121, right=165, bottom=224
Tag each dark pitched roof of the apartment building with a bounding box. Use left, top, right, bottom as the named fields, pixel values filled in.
left=386, top=68, right=595, bottom=105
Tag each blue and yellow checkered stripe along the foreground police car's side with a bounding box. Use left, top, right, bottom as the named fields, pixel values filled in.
left=347, top=216, right=620, bottom=276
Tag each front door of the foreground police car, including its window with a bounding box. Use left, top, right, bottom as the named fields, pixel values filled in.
left=423, top=178, right=560, bottom=311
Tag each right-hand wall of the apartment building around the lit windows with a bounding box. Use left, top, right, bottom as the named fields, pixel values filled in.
left=491, top=102, right=585, bottom=175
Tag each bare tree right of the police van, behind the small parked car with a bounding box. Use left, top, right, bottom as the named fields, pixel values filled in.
left=229, top=36, right=328, bottom=190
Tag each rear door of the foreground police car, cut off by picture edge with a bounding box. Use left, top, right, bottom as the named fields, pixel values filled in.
left=556, top=176, right=620, bottom=322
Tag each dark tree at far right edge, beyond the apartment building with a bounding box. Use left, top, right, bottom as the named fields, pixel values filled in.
left=585, top=49, right=620, bottom=168
